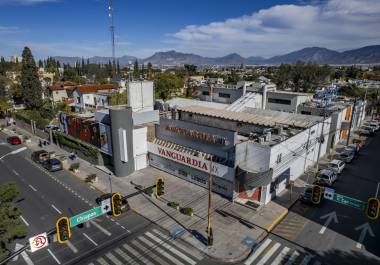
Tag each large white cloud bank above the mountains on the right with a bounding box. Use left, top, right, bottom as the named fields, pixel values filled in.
left=170, top=0, right=380, bottom=56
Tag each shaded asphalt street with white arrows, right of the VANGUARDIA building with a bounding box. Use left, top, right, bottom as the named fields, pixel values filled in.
left=244, top=132, right=380, bottom=265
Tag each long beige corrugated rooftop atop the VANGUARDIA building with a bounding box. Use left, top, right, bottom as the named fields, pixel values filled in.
left=178, top=106, right=322, bottom=128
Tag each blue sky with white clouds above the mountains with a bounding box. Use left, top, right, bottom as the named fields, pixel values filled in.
left=0, top=0, right=380, bottom=58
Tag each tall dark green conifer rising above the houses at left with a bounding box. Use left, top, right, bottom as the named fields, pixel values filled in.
left=21, top=47, right=42, bottom=109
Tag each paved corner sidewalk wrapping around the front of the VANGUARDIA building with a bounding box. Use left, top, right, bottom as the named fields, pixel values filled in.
left=3, top=124, right=352, bottom=263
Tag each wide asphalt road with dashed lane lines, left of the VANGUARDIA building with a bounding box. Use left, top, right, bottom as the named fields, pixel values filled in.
left=0, top=134, right=218, bottom=265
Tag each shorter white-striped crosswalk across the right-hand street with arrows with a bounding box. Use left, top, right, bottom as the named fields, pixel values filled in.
left=244, top=238, right=322, bottom=265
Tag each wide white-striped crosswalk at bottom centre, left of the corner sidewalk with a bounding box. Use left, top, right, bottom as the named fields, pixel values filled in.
left=87, top=229, right=203, bottom=265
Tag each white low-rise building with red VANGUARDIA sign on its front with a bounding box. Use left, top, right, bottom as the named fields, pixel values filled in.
left=148, top=106, right=330, bottom=205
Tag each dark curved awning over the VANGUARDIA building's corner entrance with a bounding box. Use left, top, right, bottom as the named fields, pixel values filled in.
left=236, top=166, right=273, bottom=189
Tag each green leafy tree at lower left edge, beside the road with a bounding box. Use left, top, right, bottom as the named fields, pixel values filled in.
left=0, top=182, right=28, bottom=260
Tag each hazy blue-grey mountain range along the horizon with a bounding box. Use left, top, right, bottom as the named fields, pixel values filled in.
left=53, top=45, right=380, bottom=65
